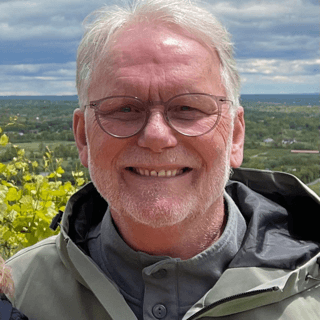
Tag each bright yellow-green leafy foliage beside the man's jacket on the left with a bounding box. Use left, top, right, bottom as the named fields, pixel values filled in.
left=0, top=128, right=86, bottom=258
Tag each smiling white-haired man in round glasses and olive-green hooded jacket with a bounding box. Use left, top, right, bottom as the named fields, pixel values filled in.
left=5, top=0, right=320, bottom=320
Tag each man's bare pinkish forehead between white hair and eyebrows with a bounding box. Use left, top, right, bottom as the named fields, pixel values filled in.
left=92, top=23, right=224, bottom=97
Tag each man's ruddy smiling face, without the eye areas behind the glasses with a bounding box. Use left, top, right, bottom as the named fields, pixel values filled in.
left=75, top=24, right=243, bottom=227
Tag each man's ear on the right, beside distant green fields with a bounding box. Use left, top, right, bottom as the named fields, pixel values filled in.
left=230, top=107, right=245, bottom=168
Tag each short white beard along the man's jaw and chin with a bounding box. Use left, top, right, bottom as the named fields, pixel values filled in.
left=88, top=126, right=233, bottom=228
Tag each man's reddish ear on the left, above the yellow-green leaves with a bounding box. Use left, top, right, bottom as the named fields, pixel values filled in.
left=73, top=109, right=88, bottom=168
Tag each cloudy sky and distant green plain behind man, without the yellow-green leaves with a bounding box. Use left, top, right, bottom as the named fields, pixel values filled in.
left=0, top=0, right=320, bottom=190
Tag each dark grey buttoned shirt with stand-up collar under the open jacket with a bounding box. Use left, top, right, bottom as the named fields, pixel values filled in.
left=87, top=193, right=246, bottom=320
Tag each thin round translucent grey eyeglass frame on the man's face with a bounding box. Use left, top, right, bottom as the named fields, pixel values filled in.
left=85, top=93, right=233, bottom=139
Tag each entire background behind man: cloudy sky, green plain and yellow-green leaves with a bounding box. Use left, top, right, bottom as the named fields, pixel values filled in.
left=0, top=0, right=320, bottom=258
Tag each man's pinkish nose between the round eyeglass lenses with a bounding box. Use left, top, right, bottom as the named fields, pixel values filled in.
left=138, top=108, right=178, bottom=153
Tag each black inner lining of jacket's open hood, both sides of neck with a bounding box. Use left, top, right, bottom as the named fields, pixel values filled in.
left=61, top=169, right=320, bottom=270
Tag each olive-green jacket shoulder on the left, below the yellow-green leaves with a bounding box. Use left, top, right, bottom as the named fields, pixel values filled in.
left=7, top=233, right=111, bottom=320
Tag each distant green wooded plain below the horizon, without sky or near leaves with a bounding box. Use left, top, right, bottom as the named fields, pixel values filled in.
left=0, top=94, right=320, bottom=195
